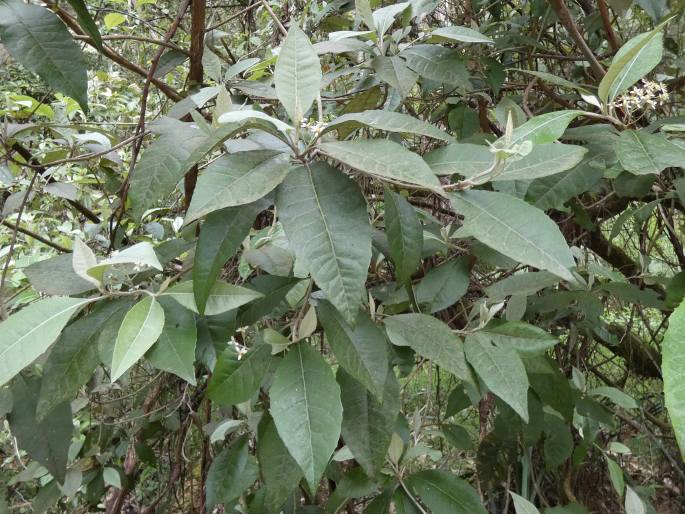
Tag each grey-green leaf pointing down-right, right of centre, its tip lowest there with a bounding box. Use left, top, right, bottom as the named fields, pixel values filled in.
left=464, top=332, right=528, bottom=423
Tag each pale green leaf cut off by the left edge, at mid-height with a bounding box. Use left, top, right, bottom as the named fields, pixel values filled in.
left=0, top=297, right=92, bottom=386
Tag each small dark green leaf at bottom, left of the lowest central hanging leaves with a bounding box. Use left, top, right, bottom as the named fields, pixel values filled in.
left=206, top=436, right=259, bottom=507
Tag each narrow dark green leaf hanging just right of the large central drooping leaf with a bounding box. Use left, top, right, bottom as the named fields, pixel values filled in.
left=383, top=187, right=423, bottom=283
